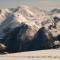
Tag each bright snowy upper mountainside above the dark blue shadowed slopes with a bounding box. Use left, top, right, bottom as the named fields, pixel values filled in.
left=0, top=6, right=60, bottom=38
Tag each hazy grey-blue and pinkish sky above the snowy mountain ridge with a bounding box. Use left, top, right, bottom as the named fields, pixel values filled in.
left=0, top=0, right=60, bottom=8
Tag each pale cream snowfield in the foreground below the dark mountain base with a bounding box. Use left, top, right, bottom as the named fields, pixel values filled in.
left=0, top=49, right=60, bottom=60
